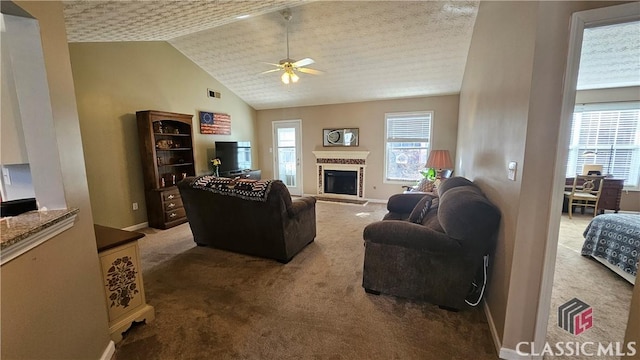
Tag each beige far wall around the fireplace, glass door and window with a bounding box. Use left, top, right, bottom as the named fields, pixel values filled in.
left=252, top=95, right=458, bottom=200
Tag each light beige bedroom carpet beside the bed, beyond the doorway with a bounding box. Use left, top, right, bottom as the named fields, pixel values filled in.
left=545, top=214, right=633, bottom=359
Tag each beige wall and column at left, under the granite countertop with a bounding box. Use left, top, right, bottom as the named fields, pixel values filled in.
left=0, top=2, right=110, bottom=359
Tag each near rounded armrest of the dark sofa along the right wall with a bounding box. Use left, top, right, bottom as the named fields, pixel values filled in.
left=363, top=220, right=462, bottom=254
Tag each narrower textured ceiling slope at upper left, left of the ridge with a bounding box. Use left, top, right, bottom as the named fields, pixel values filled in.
left=63, top=0, right=308, bottom=42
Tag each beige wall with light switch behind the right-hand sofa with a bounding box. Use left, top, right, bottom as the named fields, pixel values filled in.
left=456, top=2, right=537, bottom=346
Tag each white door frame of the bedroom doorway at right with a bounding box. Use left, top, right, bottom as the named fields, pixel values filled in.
left=533, top=3, right=640, bottom=353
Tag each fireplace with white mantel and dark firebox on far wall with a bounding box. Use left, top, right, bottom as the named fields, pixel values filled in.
left=313, top=151, right=369, bottom=199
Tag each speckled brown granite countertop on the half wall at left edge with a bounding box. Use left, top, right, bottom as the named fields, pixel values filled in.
left=0, top=208, right=79, bottom=250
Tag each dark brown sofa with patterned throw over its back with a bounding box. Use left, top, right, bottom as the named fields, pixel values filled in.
left=178, top=176, right=316, bottom=263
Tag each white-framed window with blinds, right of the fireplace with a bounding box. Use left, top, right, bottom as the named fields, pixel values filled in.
left=384, top=111, right=433, bottom=182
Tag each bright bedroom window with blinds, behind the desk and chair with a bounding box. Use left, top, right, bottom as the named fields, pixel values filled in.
left=566, top=102, right=640, bottom=189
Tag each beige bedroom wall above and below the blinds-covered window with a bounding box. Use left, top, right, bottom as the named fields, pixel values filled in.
left=576, top=86, right=640, bottom=211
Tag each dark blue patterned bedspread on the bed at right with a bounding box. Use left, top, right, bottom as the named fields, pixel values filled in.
left=582, top=214, right=640, bottom=276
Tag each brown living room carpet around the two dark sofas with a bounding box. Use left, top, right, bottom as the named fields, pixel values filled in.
left=115, top=201, right=497, bottom=360
